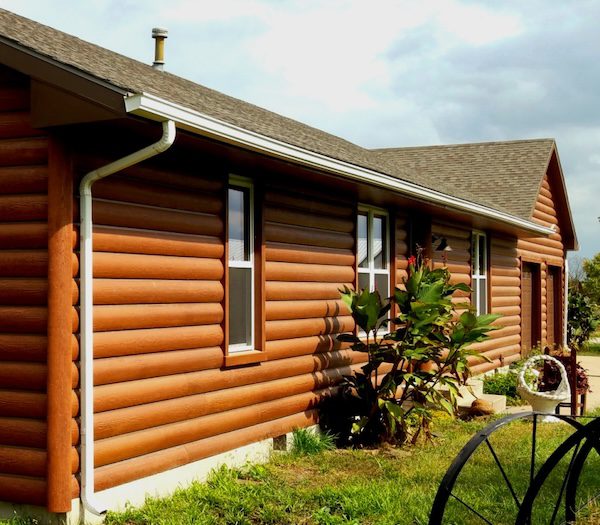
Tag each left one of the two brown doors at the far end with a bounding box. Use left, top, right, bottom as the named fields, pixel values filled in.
left=521, top=262, right=542, bottom=354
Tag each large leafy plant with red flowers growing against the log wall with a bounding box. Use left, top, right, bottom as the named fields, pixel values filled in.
left=338, top=255, right=499, bottom=446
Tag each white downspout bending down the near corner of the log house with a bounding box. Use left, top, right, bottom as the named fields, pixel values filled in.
left=79, top=120, right=176, bottom=515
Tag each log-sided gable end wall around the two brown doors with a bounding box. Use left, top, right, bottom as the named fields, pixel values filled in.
left=517, top=175, right=566, bottom=350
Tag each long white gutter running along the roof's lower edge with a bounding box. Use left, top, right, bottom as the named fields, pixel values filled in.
left=125, top=93, right=554, bottom=236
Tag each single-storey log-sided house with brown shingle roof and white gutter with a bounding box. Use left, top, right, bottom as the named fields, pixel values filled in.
left=0, top=10, right=576, bottom=520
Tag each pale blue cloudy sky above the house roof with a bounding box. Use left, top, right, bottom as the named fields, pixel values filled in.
left=0, top=0, right=600, bottom=258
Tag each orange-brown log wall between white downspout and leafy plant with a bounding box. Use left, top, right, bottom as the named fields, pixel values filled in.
left=71, top=152, right=363, bottom=490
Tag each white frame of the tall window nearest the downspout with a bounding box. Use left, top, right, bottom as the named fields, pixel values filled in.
left=227, top=174, right=256, bottom=354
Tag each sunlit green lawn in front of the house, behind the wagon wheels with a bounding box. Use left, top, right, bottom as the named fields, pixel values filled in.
left=98, top=418, right=600, bottom=525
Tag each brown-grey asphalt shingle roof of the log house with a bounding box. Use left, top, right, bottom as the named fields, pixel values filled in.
left=0, top=9, right=553, bottom=220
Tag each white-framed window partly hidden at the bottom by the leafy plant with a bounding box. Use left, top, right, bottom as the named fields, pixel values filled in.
left=356, top=208, right=390, bottom=297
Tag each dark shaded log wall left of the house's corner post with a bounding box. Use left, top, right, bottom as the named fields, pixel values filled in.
left=0, top=68, right=78, bottom=505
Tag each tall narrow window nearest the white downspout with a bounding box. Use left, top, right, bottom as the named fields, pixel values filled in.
left=227, top=176, right=254, bottom=354
